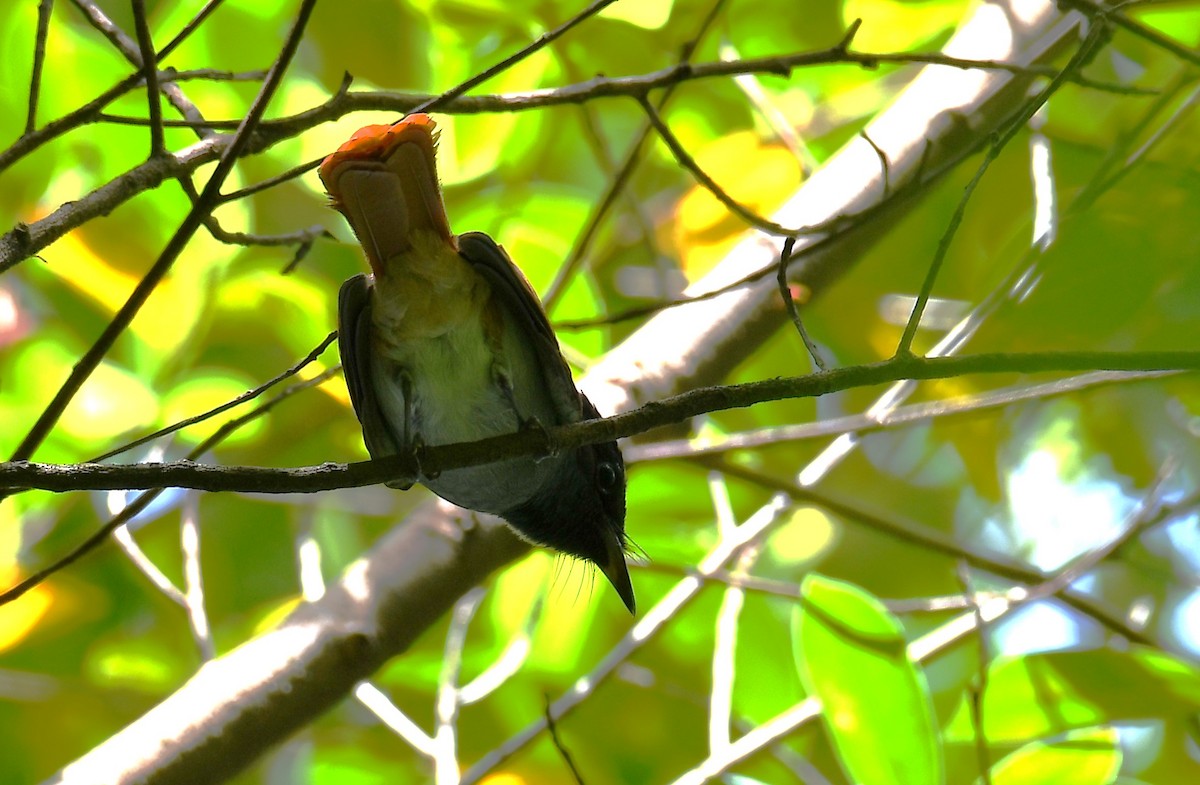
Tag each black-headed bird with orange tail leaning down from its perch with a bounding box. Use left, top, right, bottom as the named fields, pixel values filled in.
left=319, top=113, right=636, bottom=613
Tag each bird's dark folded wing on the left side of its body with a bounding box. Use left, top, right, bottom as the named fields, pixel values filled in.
left=337, top=274, right=398, bottom=459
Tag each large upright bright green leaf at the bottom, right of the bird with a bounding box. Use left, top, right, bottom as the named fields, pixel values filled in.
left=793, top=575, right=944, bottom=785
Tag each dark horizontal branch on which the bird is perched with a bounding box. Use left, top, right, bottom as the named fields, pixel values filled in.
left=0, top=352, right=1200, bottom=493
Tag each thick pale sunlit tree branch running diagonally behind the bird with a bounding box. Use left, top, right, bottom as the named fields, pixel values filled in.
left=35, top=2, right=1104, bottom=783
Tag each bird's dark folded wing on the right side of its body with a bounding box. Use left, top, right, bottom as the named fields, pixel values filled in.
left=458, top=232, right=583, bottom=425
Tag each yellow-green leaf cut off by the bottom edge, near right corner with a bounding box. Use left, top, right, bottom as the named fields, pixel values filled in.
left=991, top=727, right=1121, bottom=785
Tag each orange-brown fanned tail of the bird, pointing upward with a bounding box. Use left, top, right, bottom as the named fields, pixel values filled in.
left=319, top=114, right=455, bottom=276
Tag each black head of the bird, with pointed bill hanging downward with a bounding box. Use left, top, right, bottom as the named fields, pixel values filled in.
left=503, top=424, right=636, bottom=613
